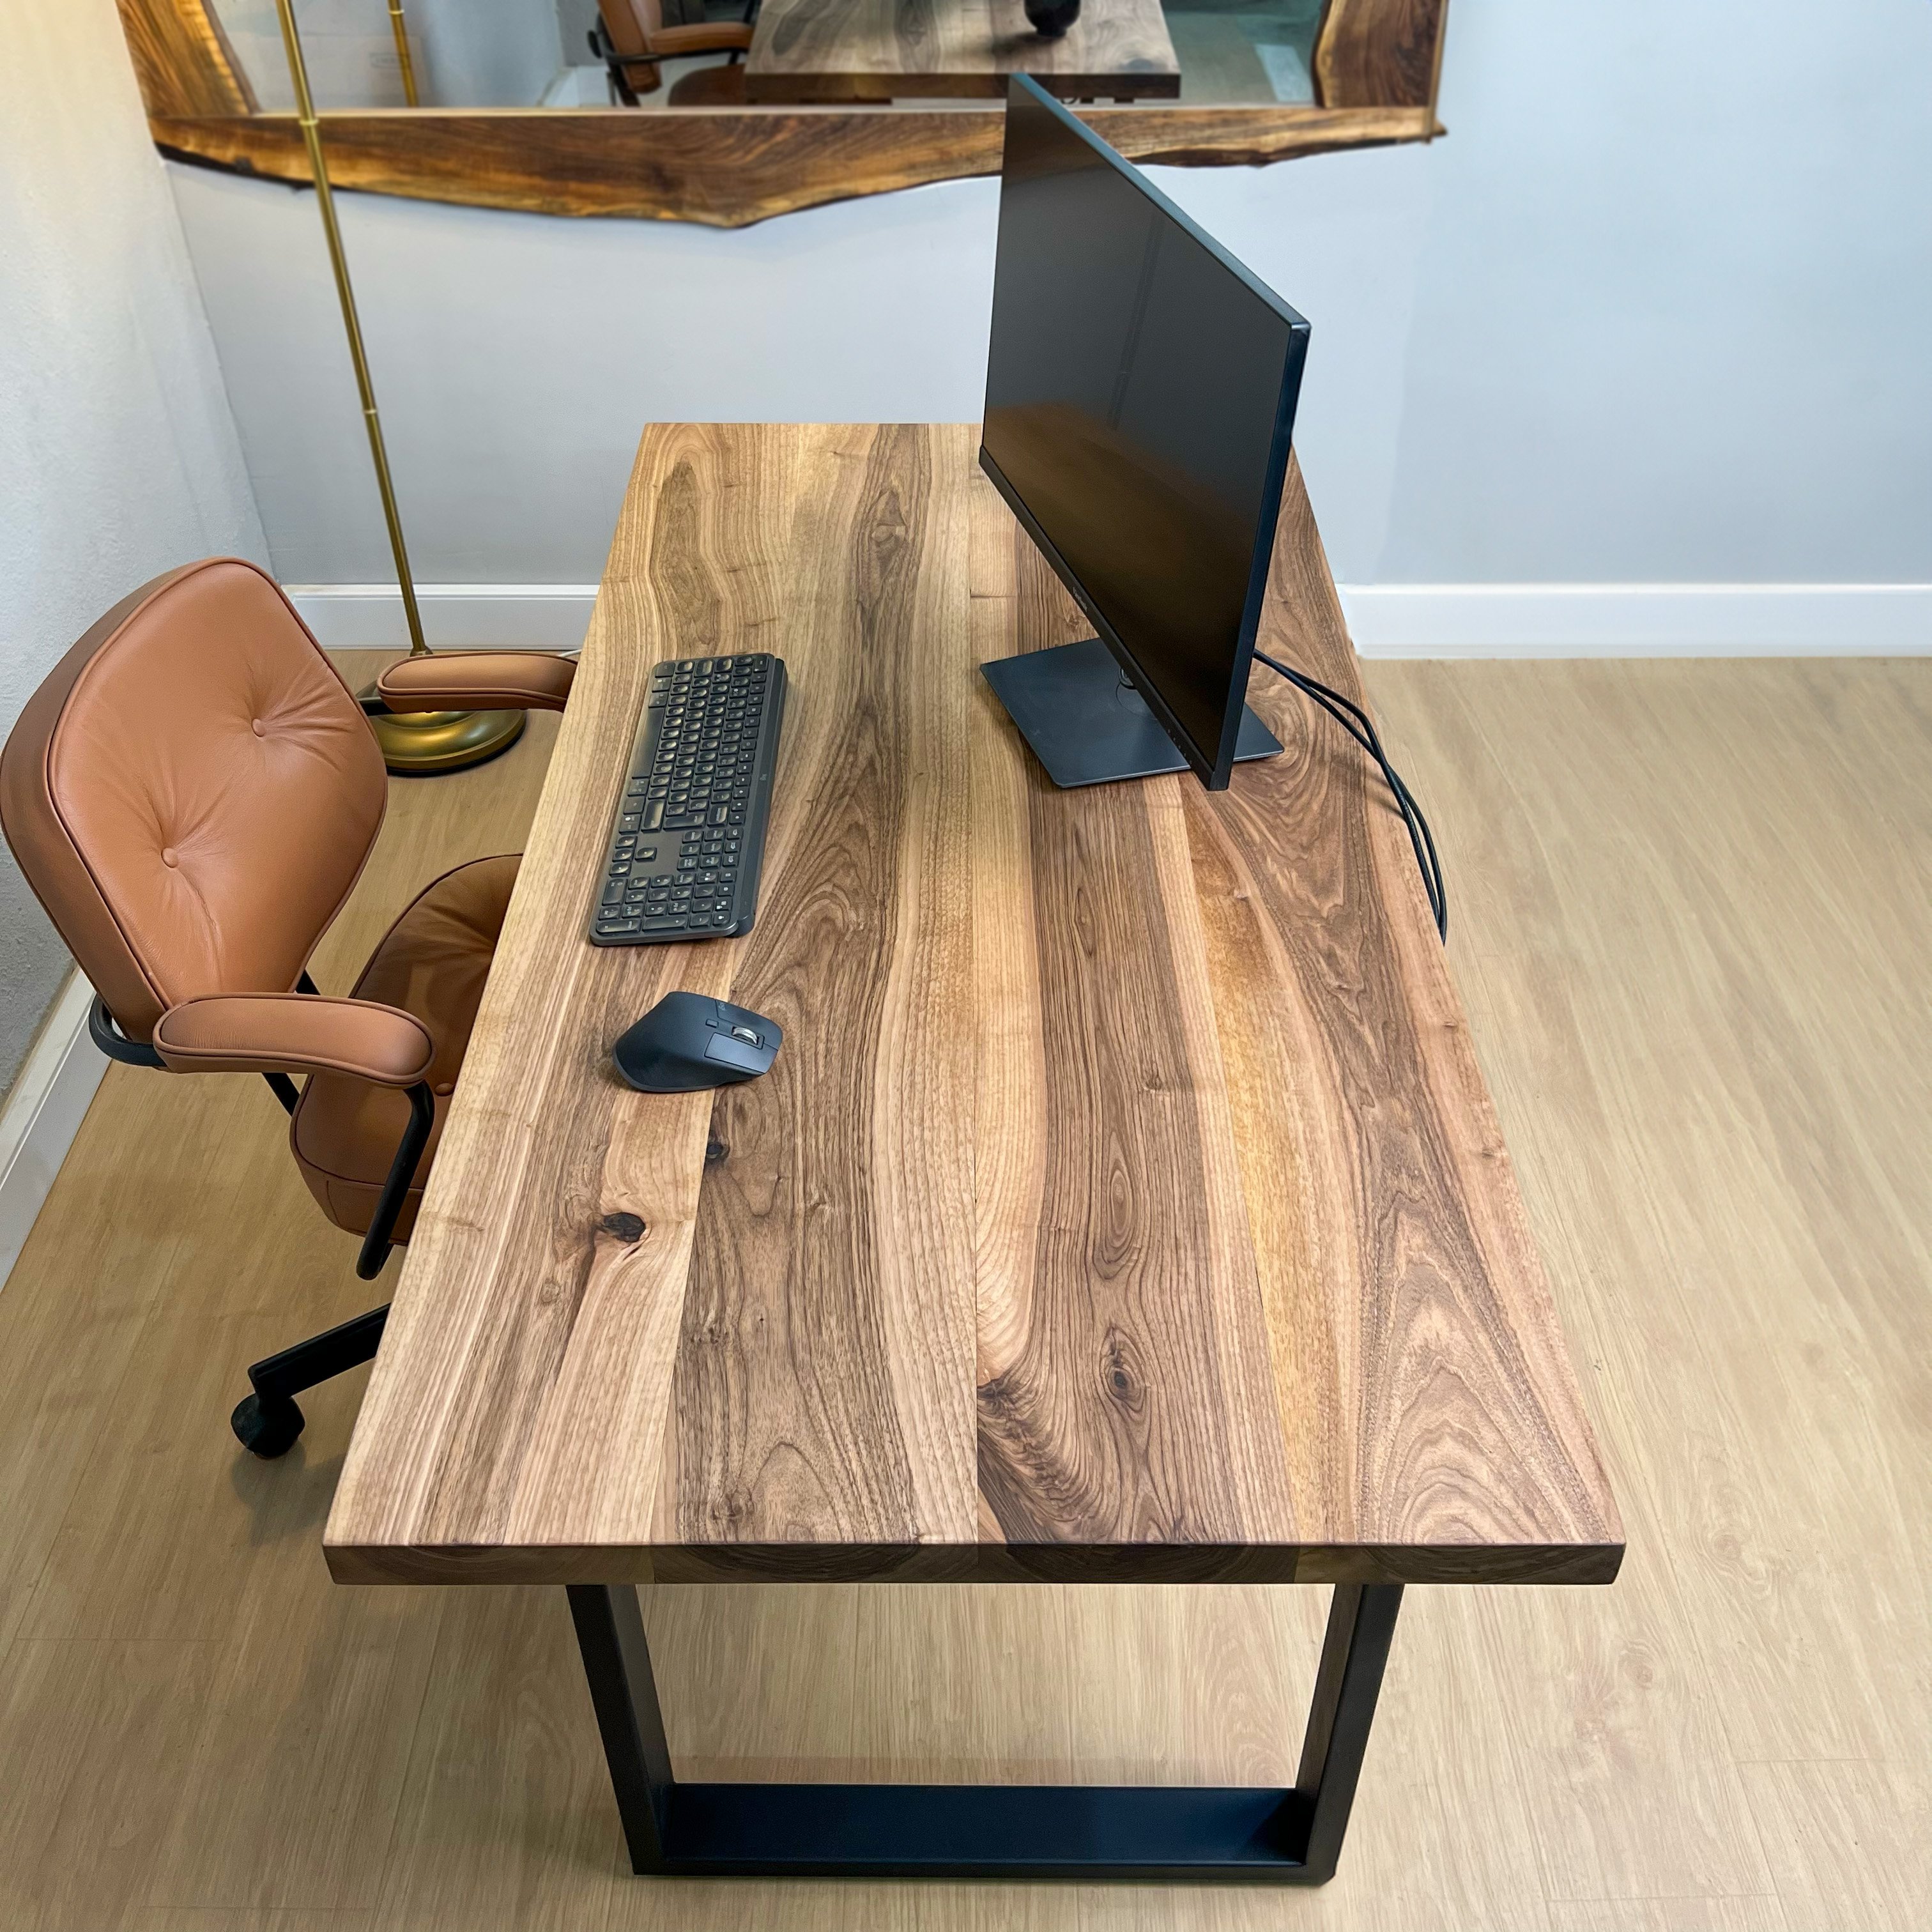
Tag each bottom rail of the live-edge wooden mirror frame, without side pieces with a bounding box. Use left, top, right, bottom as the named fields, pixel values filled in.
left=149, top=106, right=1441, bottom=228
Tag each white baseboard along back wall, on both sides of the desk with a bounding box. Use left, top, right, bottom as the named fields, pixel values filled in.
left=288, top=583, right=1932, bottom=657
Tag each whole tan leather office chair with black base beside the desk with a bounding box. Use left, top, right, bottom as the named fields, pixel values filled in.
left=0, top=558, right=576, bottom=1457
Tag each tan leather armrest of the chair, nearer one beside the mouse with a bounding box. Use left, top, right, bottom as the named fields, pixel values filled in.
left=155, top=993, right=434, bottom=1088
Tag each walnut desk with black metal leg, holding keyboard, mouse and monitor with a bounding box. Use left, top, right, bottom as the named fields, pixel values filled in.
left=326, top=425, right=1623, bottom=1882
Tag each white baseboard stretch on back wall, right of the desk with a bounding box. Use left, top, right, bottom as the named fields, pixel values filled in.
left=1341, top=583, right=1932, bottom=657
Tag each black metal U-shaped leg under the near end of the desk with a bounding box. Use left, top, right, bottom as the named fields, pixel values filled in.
left=570, top=1584, right=1402, bottom=1885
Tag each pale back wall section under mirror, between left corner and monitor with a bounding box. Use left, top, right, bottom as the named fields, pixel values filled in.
left=170, top=168, right=993, bottom=583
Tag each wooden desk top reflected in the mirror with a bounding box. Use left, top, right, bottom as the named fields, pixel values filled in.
left=744, top=0, right=1181, bottom=100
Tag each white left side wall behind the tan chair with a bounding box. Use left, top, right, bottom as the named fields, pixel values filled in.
left=0, top=0, right=268, bottom=1088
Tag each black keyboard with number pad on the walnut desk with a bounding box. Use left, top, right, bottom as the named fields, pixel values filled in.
left=591, top=651, right=785, bottom=947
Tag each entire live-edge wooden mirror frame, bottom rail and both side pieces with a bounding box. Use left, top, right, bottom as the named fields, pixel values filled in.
left=118, top=0, right=1447, bottom=228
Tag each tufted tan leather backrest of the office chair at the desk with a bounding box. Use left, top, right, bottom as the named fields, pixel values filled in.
left=0, top=556, right=388, bottom=1041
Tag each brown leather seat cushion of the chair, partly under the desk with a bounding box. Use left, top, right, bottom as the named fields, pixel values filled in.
left=288, top=854, right=519, bottom=1240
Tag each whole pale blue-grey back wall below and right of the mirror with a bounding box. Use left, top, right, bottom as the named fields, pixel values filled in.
left=174, top=0, right=1932, bottom=624
